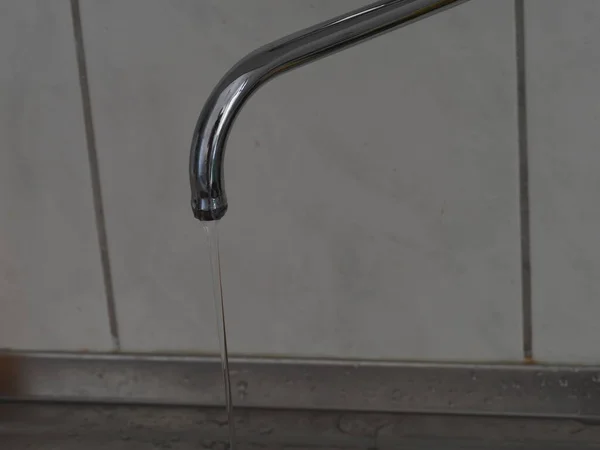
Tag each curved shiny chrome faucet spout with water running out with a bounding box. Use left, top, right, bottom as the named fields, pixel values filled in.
left=189, top=0, right=467, bottom=221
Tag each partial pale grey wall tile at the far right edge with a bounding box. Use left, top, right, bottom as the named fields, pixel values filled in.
left=525, top=0, right=600, bottom=363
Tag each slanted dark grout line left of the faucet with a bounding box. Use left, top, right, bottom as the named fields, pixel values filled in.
left=71, top=0, right=121, bottom=351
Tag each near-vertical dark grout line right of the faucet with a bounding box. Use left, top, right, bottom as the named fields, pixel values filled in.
left=515, top=0, right=533, bottom=361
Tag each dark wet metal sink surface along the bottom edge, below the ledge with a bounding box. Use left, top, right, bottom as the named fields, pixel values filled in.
left=0, top=403, right=600, bottom=450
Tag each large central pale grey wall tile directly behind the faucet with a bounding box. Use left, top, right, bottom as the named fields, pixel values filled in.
left=83, top=0, right=521, bottom=360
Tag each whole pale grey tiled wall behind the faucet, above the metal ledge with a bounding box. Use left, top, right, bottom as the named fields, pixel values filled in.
left=0, top=0, right=600, bottom=362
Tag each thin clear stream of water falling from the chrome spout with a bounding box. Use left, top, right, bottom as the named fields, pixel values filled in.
left=203, top=220, right=236, bottom=450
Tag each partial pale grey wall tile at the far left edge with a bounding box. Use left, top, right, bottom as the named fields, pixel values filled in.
left=0, top=0, right=111, bottom=350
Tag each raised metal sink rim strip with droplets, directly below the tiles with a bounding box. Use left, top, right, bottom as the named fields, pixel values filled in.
left=0, top=353, right=600, bottom=419
